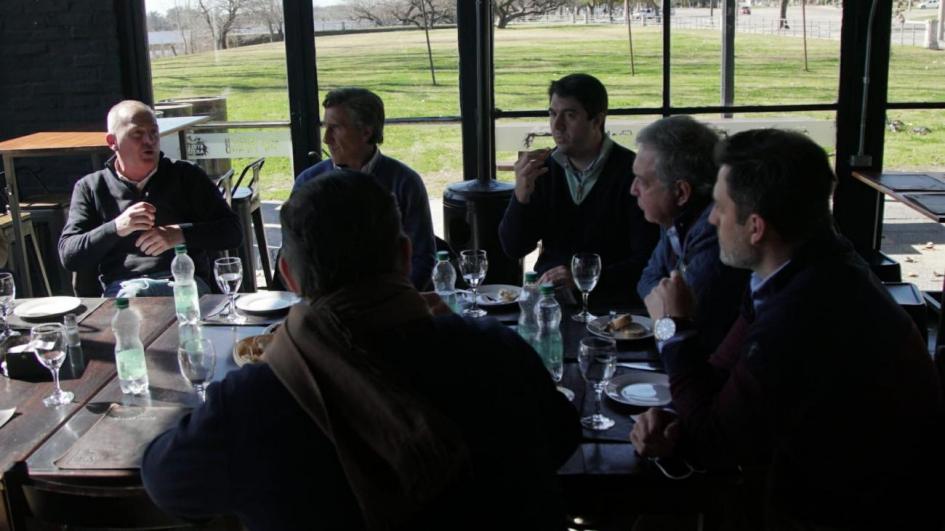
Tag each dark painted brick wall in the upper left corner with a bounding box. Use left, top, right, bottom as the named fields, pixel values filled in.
left=0, top=0, right=126, bottom=195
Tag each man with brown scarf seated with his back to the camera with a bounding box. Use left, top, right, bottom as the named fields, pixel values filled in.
left=142, top=171, right=580, bottom=530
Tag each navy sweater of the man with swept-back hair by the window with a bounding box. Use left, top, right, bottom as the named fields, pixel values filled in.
left=292, top=153, right=436, bottom=289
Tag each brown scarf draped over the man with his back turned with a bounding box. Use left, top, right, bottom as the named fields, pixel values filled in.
left=263, top=275, right=470, bottom=529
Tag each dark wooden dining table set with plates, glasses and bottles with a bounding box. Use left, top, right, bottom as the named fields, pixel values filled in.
left=0, top=295, right=732, bottom=529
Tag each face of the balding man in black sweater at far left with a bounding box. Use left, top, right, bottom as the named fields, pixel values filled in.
left=106, top=111, right=161, bottom=180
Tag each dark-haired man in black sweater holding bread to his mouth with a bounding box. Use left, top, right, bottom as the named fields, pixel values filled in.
left=499, top=74, right=659, bottom=304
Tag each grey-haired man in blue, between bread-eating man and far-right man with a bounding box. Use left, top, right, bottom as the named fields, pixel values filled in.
left=630, top=116, right=748, bottom=354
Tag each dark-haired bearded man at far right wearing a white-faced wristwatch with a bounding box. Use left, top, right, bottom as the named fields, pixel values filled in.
left=631, top=129, right=945, bottom=530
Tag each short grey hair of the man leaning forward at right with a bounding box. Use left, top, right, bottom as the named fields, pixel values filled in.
left=637, top=115, right=719, bottom=197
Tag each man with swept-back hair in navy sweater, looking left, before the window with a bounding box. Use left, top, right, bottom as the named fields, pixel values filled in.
left=292, top=87, right=436, bottom=289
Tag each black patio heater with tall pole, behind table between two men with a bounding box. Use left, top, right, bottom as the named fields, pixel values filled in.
left=443, top=0, right=522, bottom=285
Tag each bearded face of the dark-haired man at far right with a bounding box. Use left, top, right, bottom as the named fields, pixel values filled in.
left=709, top=165, right=761, bottom=269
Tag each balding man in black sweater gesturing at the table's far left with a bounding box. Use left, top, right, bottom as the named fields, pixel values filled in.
left=59, top=100, right=242, bottom=297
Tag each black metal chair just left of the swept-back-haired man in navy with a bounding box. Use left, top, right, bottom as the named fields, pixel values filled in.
left=231, top=157, right=272, bottom=292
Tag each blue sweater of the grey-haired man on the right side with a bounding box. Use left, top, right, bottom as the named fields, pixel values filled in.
left=637, top=201, right=750, bottom=349
